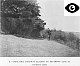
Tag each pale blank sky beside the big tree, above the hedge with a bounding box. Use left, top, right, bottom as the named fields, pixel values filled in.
left=37, top=0, right=80, bottom=32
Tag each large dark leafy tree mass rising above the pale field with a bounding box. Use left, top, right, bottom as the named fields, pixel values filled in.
left=1, top=0, right=45, bottom=35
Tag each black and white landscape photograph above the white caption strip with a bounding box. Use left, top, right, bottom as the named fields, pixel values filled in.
left=0, top=0, right=80, bottom=57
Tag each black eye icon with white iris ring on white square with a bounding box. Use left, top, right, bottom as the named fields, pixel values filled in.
left=65, top=3, right=79, bottom=13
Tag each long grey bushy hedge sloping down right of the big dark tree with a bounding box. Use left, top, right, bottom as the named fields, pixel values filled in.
left=42, top=30, right=80, bottom=50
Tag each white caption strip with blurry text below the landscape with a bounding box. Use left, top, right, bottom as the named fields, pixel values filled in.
left=0, top=57, right=80, bottom=66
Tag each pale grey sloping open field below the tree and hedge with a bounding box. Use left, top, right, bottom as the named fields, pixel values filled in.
left=0, top=35, right=77, bottom=57
